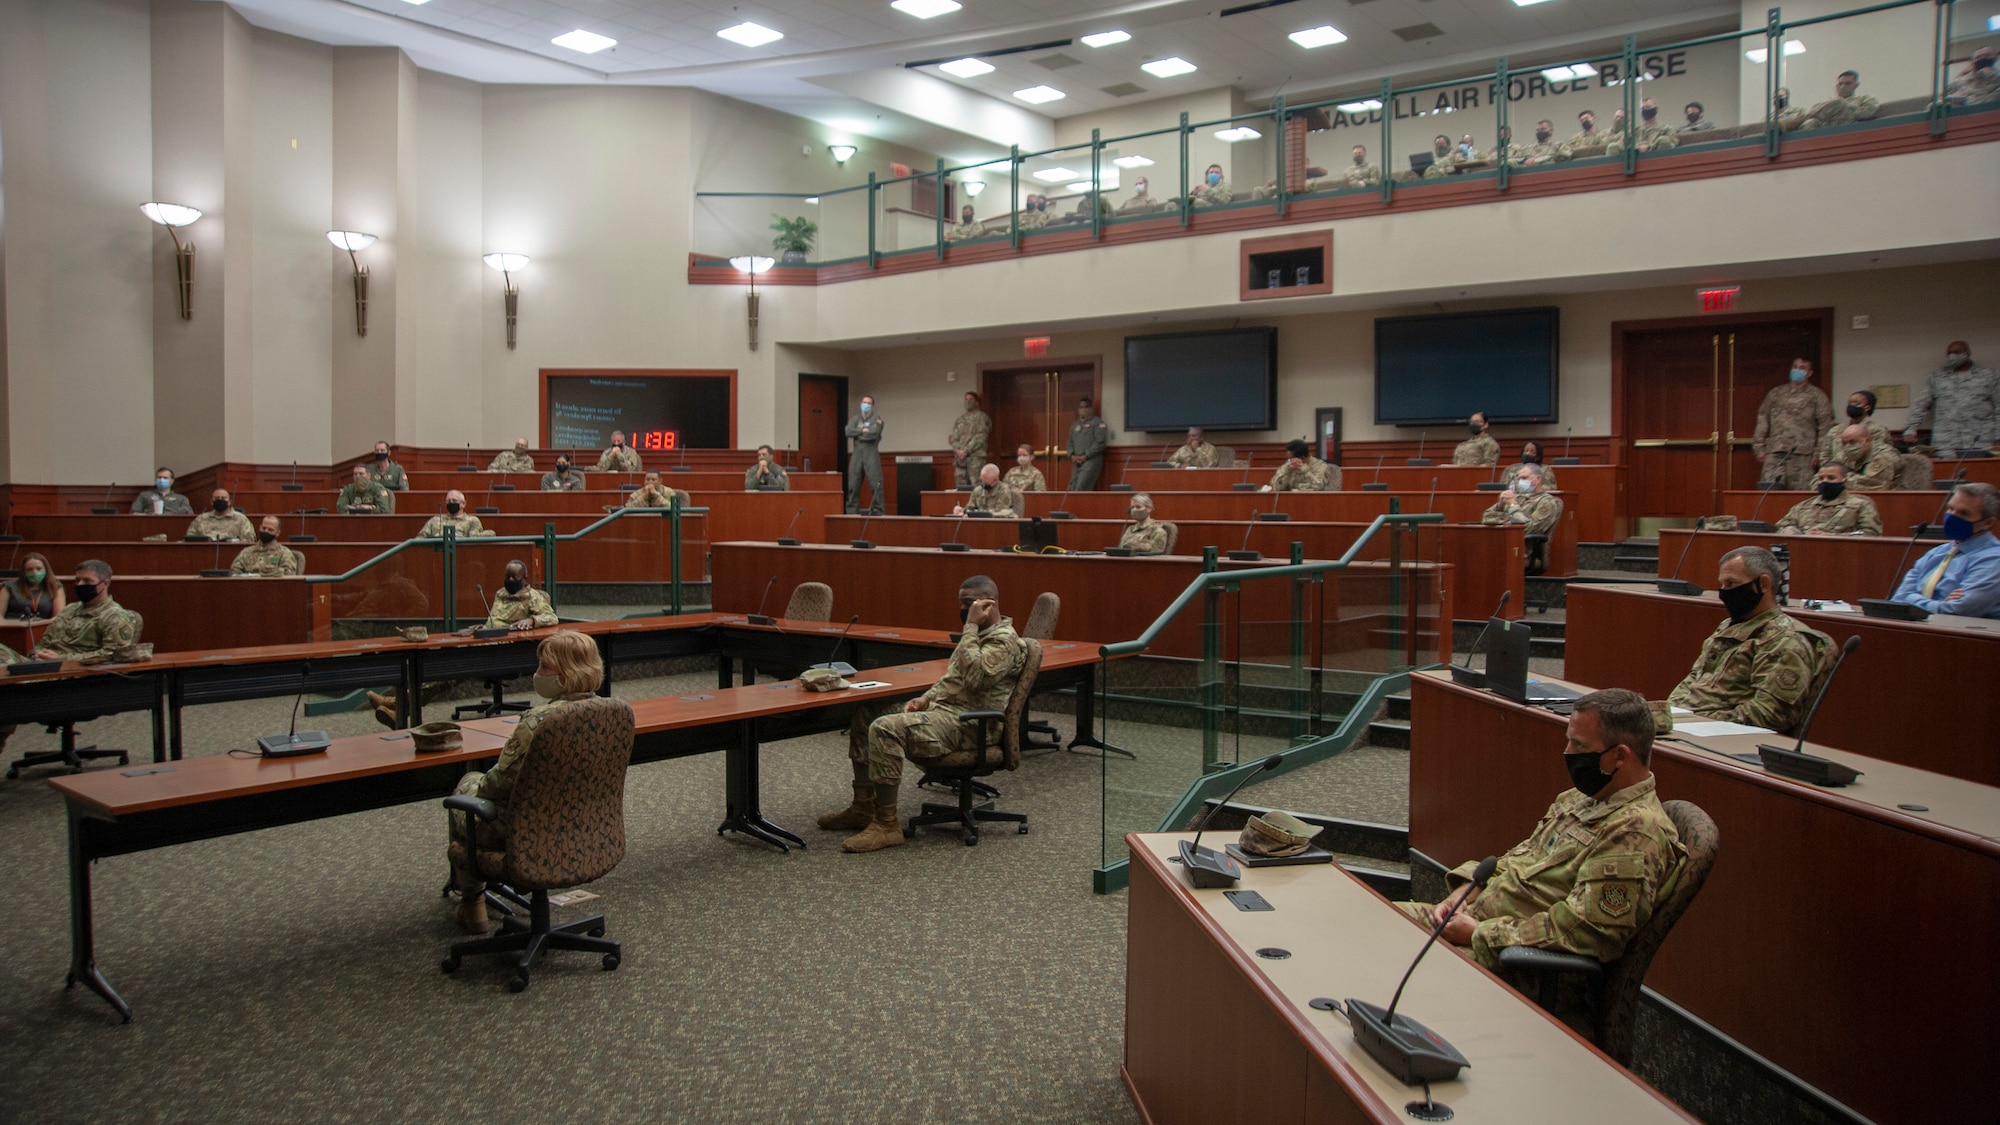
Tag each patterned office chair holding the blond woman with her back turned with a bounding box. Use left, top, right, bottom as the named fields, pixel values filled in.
left=442, top=697, right=634, bottom=993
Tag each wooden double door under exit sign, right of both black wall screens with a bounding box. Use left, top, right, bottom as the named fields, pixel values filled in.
left=1612, top=310, right=1832, bottom=520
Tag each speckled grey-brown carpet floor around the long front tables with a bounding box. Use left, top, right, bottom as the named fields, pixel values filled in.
left=0, top=675, right=1406, bottom=1123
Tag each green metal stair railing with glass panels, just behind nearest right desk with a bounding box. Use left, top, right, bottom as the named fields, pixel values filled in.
left=1092, top=512, right=1450, bottom=893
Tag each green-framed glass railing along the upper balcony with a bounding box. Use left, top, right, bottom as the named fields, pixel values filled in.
left=696, top=0, right=2000, bottom=268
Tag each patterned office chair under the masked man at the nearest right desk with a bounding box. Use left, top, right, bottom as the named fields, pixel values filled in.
left=1500, top=801, right=1722, bottom=1067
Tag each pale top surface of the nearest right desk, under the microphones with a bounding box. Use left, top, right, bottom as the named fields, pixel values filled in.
left=1126, top=833, right=1692, bottom=1125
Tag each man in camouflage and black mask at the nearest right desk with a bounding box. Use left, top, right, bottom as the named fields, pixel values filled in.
left=1396, top=689, right=1688, bottom=969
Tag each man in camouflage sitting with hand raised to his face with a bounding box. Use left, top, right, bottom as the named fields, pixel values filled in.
left=820, top=575, right=1026, bottom=851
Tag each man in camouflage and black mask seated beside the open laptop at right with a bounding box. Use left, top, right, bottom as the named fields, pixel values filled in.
left=1666, top=546, right=1834, bottom=731
